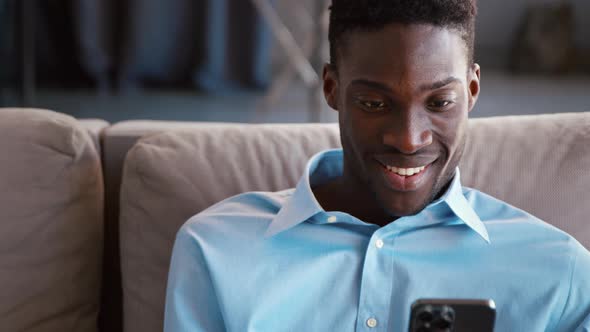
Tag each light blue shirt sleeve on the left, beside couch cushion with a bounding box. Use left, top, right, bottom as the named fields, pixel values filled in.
left=164, top=227, right=225, bottom=332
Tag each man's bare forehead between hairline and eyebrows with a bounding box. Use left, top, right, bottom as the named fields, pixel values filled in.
left=338, top=24, right=467, bottom=81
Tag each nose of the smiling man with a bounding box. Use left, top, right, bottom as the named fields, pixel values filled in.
left=383, top=110, right=432, bottom=154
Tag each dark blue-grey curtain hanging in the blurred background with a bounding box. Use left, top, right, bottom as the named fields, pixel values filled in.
left=9, top=0, right=271, bottom=92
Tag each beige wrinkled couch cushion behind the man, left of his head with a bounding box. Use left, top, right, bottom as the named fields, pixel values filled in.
left=120, top=125, right=339, bottom=332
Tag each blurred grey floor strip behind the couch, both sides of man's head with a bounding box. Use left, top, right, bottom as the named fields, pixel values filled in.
left=2, top=72, right=590, bottom=123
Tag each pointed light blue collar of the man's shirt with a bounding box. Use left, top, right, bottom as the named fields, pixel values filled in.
left=265, top=149, right=490, bottom=243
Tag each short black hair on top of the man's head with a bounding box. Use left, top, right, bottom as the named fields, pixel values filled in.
left=328, top=0, right=477, bottom=66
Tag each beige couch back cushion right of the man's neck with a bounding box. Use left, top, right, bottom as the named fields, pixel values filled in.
left=460, top=112, right=590, bottom=248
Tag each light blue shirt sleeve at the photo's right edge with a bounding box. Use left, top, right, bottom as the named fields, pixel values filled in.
left=556, top=241, right=590, bottom=332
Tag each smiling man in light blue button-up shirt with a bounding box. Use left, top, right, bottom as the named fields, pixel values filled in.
left=165, top=0, right=590, bottom=332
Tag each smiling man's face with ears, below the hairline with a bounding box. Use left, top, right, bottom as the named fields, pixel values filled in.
left=324, top=24, right=479, bottom=217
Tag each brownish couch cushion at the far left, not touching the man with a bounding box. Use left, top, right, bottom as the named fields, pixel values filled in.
left=0, top=109, right=103, bottom=332
